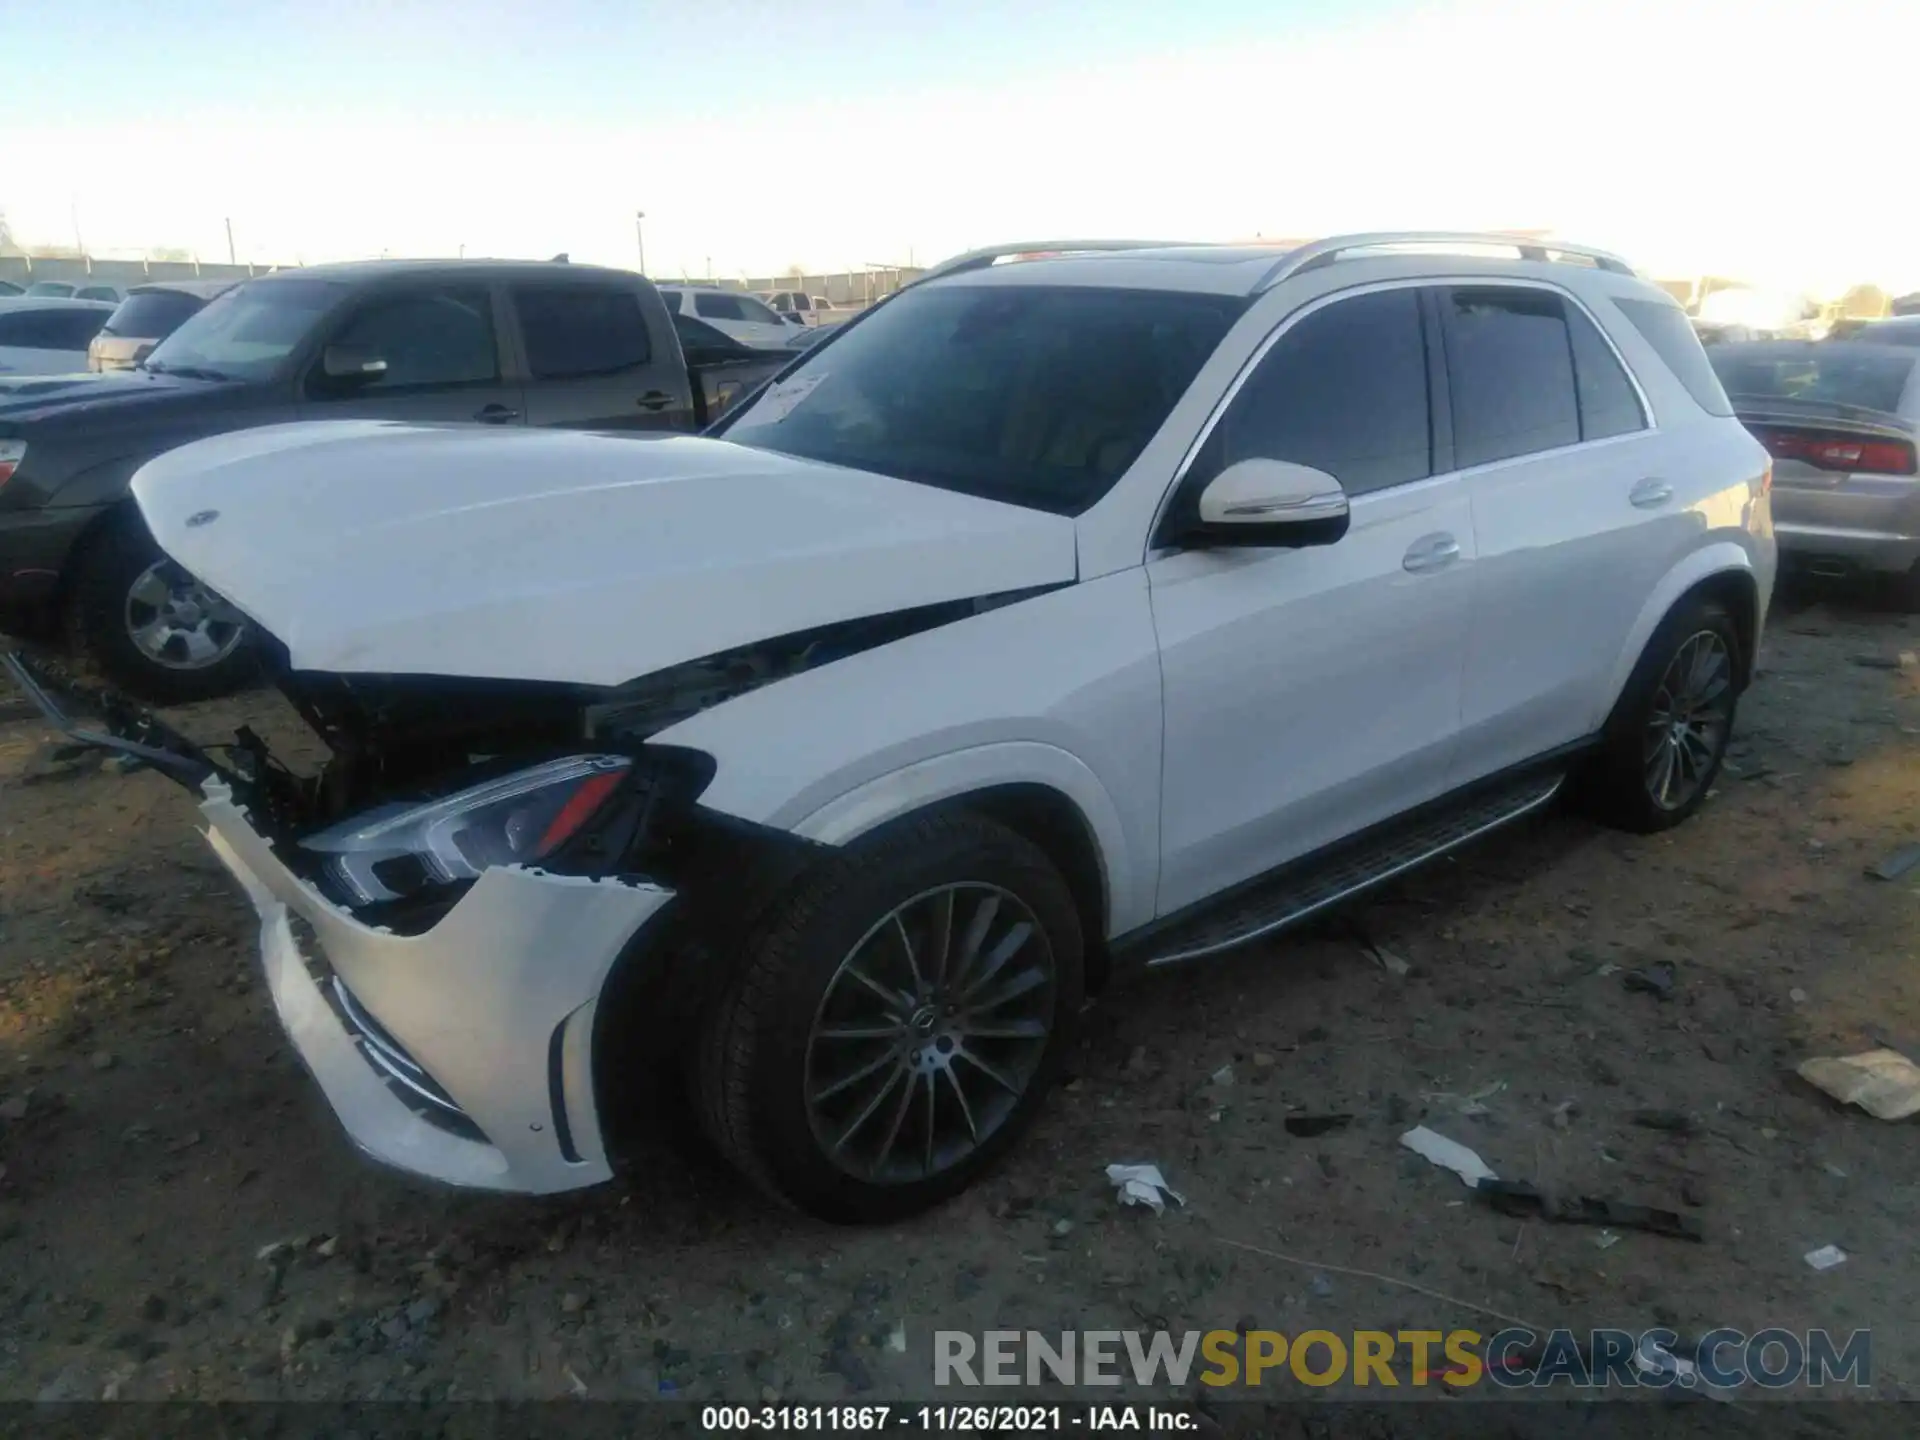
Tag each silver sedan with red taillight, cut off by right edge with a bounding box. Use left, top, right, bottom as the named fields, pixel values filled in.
left=1707, top=337, right=1920, bottom=611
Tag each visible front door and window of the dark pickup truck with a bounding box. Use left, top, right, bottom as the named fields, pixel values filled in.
left=301, top=280, right=524, bottom=424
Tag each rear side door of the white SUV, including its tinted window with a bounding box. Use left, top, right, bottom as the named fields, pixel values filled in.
left=1434, top=282, right=1695, bottom=781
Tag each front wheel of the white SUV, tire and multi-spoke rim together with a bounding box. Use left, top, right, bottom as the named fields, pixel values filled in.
left=695, top=812, right=1081, bottom=1221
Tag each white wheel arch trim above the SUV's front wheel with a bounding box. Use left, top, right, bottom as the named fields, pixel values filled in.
left=793, top=741, right=1154, bottom=935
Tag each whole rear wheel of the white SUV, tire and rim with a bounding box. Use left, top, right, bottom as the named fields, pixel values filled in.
left=1586, top=597, right=1741, bottom=831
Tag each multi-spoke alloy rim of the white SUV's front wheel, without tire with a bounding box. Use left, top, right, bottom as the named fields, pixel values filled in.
left=804, top=883, right=1056, bottom=1185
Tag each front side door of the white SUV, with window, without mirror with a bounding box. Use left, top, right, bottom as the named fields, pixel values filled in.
left=1148, top=288, right=1475, bottom=914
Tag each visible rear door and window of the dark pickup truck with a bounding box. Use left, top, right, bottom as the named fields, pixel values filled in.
left=509, top=280, right=693, bottom=430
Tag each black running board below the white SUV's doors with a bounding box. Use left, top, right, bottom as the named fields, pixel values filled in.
left=1146, top=772, right=1567, bottom=966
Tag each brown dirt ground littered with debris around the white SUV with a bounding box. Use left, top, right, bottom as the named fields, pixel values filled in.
left=0, top=579, right=1920, bottom=1402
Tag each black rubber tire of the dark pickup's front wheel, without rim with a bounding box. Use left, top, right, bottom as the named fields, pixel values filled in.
left=67, top=511, right=259, bottom=705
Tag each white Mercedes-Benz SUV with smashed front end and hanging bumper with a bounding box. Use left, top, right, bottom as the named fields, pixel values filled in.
left=10, top=234, right=1774, bottom=1221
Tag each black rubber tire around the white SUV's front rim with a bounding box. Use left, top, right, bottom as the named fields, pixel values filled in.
left=691, top=810, right=1085, bottom=1223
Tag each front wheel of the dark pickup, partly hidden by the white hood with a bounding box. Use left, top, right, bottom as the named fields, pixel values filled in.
left=69, top=515, right=255, bottom=705
